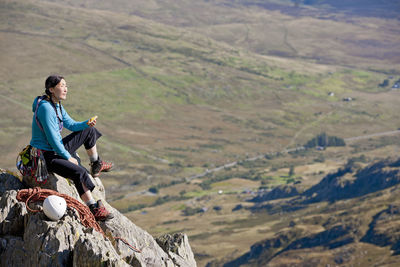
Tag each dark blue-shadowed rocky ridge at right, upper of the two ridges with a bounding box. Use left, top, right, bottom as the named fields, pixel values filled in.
left=249, top=158, right=400, bottom=214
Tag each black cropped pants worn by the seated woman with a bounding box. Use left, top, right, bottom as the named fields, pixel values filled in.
left=44, top=127, right=102, bottom=196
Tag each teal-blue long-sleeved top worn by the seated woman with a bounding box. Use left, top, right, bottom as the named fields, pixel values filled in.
left=30, top=98, right=89, bottom=159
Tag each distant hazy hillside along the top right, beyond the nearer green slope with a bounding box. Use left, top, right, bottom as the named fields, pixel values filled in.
left=39, top=0, right=400, bottom=71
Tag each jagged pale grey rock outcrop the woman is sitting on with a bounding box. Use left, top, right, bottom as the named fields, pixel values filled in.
left=0, top=173, right=196, bottom=267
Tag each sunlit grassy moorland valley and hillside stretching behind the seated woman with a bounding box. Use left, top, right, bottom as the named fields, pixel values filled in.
left=0, top=0, right=400, bottom=266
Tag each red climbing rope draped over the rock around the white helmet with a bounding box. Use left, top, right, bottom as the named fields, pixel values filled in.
left=17, top=187, right=141, bottom=253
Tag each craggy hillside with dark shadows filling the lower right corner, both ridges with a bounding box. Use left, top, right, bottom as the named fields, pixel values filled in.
left=224, top=159, right=400, bottom=266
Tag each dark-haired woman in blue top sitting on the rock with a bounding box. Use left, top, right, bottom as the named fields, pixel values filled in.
left=30, top=75, right=113, bottom=221
